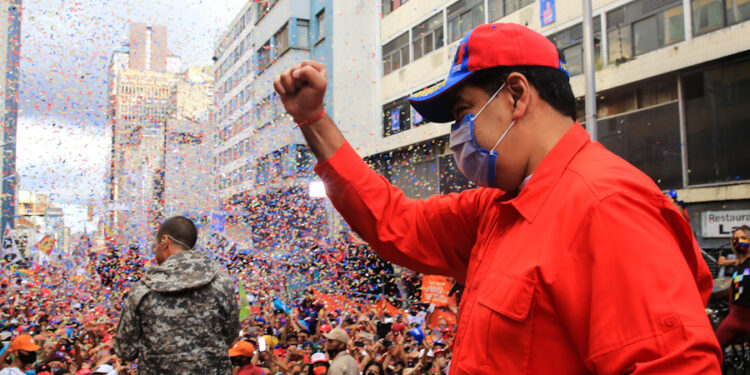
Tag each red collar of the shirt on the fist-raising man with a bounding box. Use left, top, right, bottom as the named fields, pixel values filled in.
left=499, top=122, right=591, bottom=222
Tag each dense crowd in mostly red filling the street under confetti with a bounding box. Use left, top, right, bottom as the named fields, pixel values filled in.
left=0, top=228, right=456, bottom=374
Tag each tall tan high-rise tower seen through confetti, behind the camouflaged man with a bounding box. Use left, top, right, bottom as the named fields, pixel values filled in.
left=106, top=23, right=213, bottom=248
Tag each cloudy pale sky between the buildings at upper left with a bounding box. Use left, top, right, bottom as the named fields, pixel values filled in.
left=16, top=0, right=249, bottom=232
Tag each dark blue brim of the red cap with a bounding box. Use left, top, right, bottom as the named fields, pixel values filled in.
left=409, top=71, right=474, bottom=122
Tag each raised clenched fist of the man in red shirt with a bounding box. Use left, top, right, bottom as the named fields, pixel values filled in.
left=273, top=60, right=328, bottom=121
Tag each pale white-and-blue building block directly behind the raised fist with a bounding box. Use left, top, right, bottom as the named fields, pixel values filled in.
left=214, top=0, right=379, bottom=252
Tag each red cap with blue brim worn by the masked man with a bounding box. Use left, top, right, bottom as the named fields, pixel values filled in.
left=409, top=23, right=568, bottom=122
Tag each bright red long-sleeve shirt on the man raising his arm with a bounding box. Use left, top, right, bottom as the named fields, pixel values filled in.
left=315, top=124, right=721, bottom=375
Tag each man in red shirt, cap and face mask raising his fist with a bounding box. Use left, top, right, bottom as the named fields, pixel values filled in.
left=274, top=24, right=721, bottom=375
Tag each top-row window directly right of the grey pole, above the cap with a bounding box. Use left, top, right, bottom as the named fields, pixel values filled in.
left=607, top=0, right=685, bottom=64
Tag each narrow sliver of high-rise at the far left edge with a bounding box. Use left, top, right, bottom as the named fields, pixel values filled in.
left=0, top=0, right=21, bottom=234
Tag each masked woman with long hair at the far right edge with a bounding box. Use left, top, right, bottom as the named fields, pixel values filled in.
left=716, top=225, right=750, bottom=347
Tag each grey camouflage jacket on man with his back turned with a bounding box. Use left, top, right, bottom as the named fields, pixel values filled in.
left=115, top=251, right=240, bottom=375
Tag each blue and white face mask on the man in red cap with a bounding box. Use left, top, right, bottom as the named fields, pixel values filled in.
left=450, top=83, right=516, bottom=187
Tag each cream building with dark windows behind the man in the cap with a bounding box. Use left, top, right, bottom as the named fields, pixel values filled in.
left=374, top=0, right=750, bottom=253
